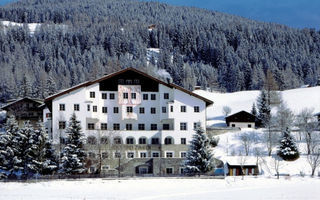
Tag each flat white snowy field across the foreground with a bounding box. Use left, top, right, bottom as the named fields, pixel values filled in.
left=0, top=177, right=320, bottom=200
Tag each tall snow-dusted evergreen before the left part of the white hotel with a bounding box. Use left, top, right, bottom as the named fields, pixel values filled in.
left=60, top=113, right=85, bottom=175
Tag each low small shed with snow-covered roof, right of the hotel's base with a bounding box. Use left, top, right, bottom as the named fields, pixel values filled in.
left=225, top=156, right=259, bottom=176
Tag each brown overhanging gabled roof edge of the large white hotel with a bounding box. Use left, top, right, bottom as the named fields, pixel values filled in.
left=45, top=67, right=213, bottom=106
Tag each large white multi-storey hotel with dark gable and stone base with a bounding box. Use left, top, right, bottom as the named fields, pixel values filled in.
left=45, top=68, right=213, bottom=175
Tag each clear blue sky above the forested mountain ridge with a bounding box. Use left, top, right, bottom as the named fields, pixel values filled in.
left=0, top=0, right=320, bottom=30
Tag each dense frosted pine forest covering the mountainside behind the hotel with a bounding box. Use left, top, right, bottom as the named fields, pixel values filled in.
left=0, top=0, right=320, bottom=101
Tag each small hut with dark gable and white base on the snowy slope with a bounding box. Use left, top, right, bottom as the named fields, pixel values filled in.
left=226, top=111, right=257, bottom=128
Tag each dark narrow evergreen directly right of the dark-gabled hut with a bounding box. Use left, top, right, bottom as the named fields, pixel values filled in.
left=257, top=90, right=271, bottom=127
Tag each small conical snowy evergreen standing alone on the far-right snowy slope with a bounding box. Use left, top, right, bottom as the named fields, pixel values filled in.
left=278, top=128, right=299, bottom=161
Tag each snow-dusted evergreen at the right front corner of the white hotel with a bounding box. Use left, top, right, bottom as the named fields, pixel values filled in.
left=185, top=125, right=213, bottom=174
